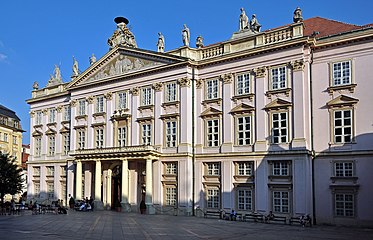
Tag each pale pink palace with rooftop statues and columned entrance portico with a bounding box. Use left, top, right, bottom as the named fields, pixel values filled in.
left=27, top=8, right=373, bottom=225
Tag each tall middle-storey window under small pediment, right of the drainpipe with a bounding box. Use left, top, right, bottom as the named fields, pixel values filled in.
left=333, top=109, right=353, bottom=143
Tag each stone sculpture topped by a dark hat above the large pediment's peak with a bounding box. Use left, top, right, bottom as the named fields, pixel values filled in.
left=108, top=17, right=137, bottom=48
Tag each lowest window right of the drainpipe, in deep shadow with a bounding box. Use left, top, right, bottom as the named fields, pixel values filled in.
left=334, top=192, right=355, bottom=217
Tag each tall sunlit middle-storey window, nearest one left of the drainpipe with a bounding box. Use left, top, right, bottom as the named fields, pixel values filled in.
left=272, top=112, right=288, bottom=143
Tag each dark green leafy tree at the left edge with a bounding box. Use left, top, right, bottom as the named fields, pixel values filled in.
left=0, top=152, right=23, bottom=203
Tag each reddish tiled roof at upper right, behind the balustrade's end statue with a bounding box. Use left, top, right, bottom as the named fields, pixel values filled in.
left=303, top=17, right=366, bottom=38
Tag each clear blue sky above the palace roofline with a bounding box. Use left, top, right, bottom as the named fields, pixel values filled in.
left=0, top=0, right=373, bottom=143
